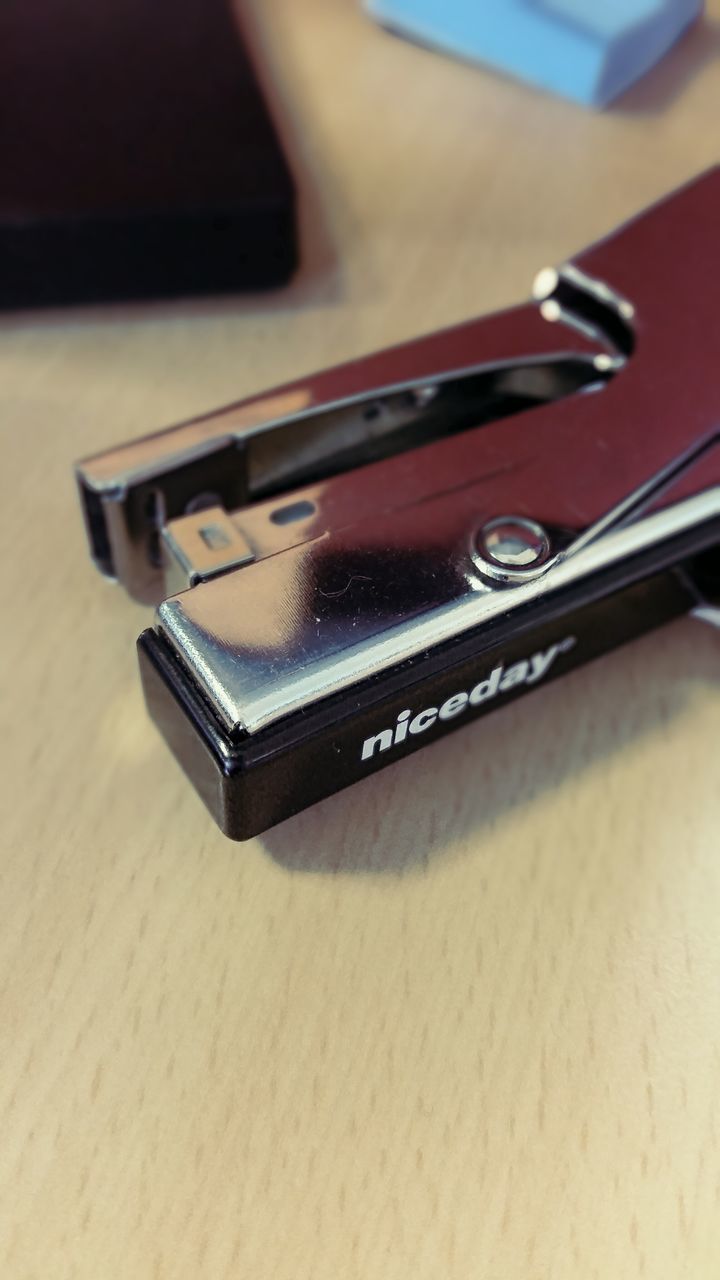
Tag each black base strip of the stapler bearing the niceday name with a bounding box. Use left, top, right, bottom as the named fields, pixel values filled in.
left=138, top=522, right=720, bottom=840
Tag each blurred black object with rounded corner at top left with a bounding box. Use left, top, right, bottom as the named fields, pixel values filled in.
left=0, top=0, right=297, bottom=308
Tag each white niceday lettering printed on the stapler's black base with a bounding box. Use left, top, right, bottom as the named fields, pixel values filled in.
left=360, top=636, right=577, bottom=760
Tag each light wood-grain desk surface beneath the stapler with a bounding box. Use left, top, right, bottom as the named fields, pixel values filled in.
left=0, top=0, right=720, bottom=1280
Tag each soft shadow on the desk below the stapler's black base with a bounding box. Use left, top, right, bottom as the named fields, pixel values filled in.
left=261, top=621, right=720, bottom=876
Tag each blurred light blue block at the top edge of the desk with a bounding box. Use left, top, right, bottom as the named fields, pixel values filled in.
left=365, top=0, right=703, bottom=106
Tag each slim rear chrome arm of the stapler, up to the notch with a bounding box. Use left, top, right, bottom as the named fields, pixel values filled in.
left=77, top=177, right=645, bottom=603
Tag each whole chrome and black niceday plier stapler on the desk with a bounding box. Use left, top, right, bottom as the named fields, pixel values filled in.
left=77, top=169, right=720, bottom=840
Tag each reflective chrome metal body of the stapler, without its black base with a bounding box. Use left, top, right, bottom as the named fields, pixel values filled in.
left=78, top=169, right=720, bottom=732
